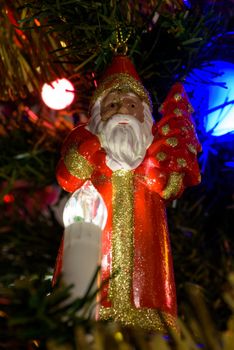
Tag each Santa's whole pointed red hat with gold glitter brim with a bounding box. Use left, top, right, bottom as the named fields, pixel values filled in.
left=91, top=55, right=152, bottom=108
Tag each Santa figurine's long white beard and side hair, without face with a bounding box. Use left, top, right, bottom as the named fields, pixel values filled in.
left=88, top=103, right=153, bottom=171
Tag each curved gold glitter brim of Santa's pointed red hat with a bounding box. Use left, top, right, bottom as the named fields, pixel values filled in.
left=91, top=73, right=152, bottom=111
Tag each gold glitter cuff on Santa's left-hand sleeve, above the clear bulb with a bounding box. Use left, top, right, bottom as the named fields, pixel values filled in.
left=64, top=147, right=93, bottom=180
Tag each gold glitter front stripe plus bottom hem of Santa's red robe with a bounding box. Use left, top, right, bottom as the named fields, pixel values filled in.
left=99, top=170, right=177, bottom=331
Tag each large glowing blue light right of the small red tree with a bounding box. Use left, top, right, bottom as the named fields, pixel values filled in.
left=185, top=61, right=234, bottom=136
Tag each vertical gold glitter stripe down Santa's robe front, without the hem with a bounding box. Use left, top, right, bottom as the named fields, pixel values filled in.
left=110, top=169, right=134, bottom=300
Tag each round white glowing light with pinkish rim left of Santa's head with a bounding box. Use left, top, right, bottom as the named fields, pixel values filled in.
left=41, top=78, right=75, bottom=110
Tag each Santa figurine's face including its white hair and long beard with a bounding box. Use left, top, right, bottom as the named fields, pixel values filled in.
left=88, top=92, right=153, bottom=171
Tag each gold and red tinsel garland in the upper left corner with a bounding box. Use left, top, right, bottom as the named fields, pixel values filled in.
left=0, top=1, right=68, bottom=101
